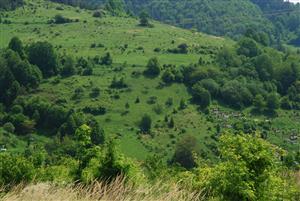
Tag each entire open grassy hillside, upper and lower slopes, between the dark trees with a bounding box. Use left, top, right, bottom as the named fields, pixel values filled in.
left=0, top=1, right=300, bottom=160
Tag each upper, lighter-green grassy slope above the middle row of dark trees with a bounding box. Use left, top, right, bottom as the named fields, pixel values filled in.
left=0, top=1, right=230, bottom=65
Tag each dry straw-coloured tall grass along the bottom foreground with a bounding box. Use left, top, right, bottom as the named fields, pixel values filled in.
left=0, top=177, right=204, bottom=201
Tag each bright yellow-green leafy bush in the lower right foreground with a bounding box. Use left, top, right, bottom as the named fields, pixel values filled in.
left=185, top=134, right=297, bottom=200
